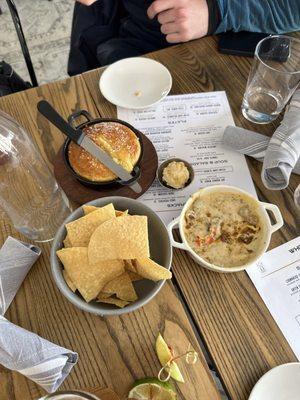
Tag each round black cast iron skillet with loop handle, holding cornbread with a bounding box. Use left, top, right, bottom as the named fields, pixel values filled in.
left=63, top=110, right=143, bottom=188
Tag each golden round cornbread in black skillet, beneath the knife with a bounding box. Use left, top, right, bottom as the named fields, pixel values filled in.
left=68, top=122, right=141, bottom=182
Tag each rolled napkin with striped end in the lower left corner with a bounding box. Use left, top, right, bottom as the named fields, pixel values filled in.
left=0, top=316, right=78, bottom=393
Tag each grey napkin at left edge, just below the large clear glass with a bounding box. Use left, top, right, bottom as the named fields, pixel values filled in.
left=0, top=236, right=41, bottom=315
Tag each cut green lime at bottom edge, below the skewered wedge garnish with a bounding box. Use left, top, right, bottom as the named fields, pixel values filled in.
left=128, top=378, right=177, bottom=400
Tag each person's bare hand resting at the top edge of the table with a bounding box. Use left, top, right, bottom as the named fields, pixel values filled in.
left=147, top=0, right=209, bottom=43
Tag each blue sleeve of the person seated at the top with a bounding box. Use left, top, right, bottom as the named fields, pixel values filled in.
left=216, top=0, right=300, bottom=34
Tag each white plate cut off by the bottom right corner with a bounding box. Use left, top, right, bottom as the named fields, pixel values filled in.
left=249, top=363, right=300, bottom=400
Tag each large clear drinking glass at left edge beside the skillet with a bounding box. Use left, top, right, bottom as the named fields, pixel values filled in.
left=0, top=111, right=71, bottom=242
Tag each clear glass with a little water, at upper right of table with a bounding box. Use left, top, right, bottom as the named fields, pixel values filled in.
left=242, top=35, right=300, bottom=124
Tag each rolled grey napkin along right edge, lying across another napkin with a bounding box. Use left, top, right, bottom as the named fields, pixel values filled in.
left=261, top=89, right=300, bottom=190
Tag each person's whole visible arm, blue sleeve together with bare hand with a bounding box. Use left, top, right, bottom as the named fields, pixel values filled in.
left=147, top=0, right=300, bottom=43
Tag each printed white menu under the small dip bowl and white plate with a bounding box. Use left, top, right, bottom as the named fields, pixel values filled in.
left=118, top=92, right=256, bottom=223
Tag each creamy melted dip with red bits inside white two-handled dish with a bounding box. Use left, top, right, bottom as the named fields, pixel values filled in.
left=184, top=192, right=265, bottom=268
